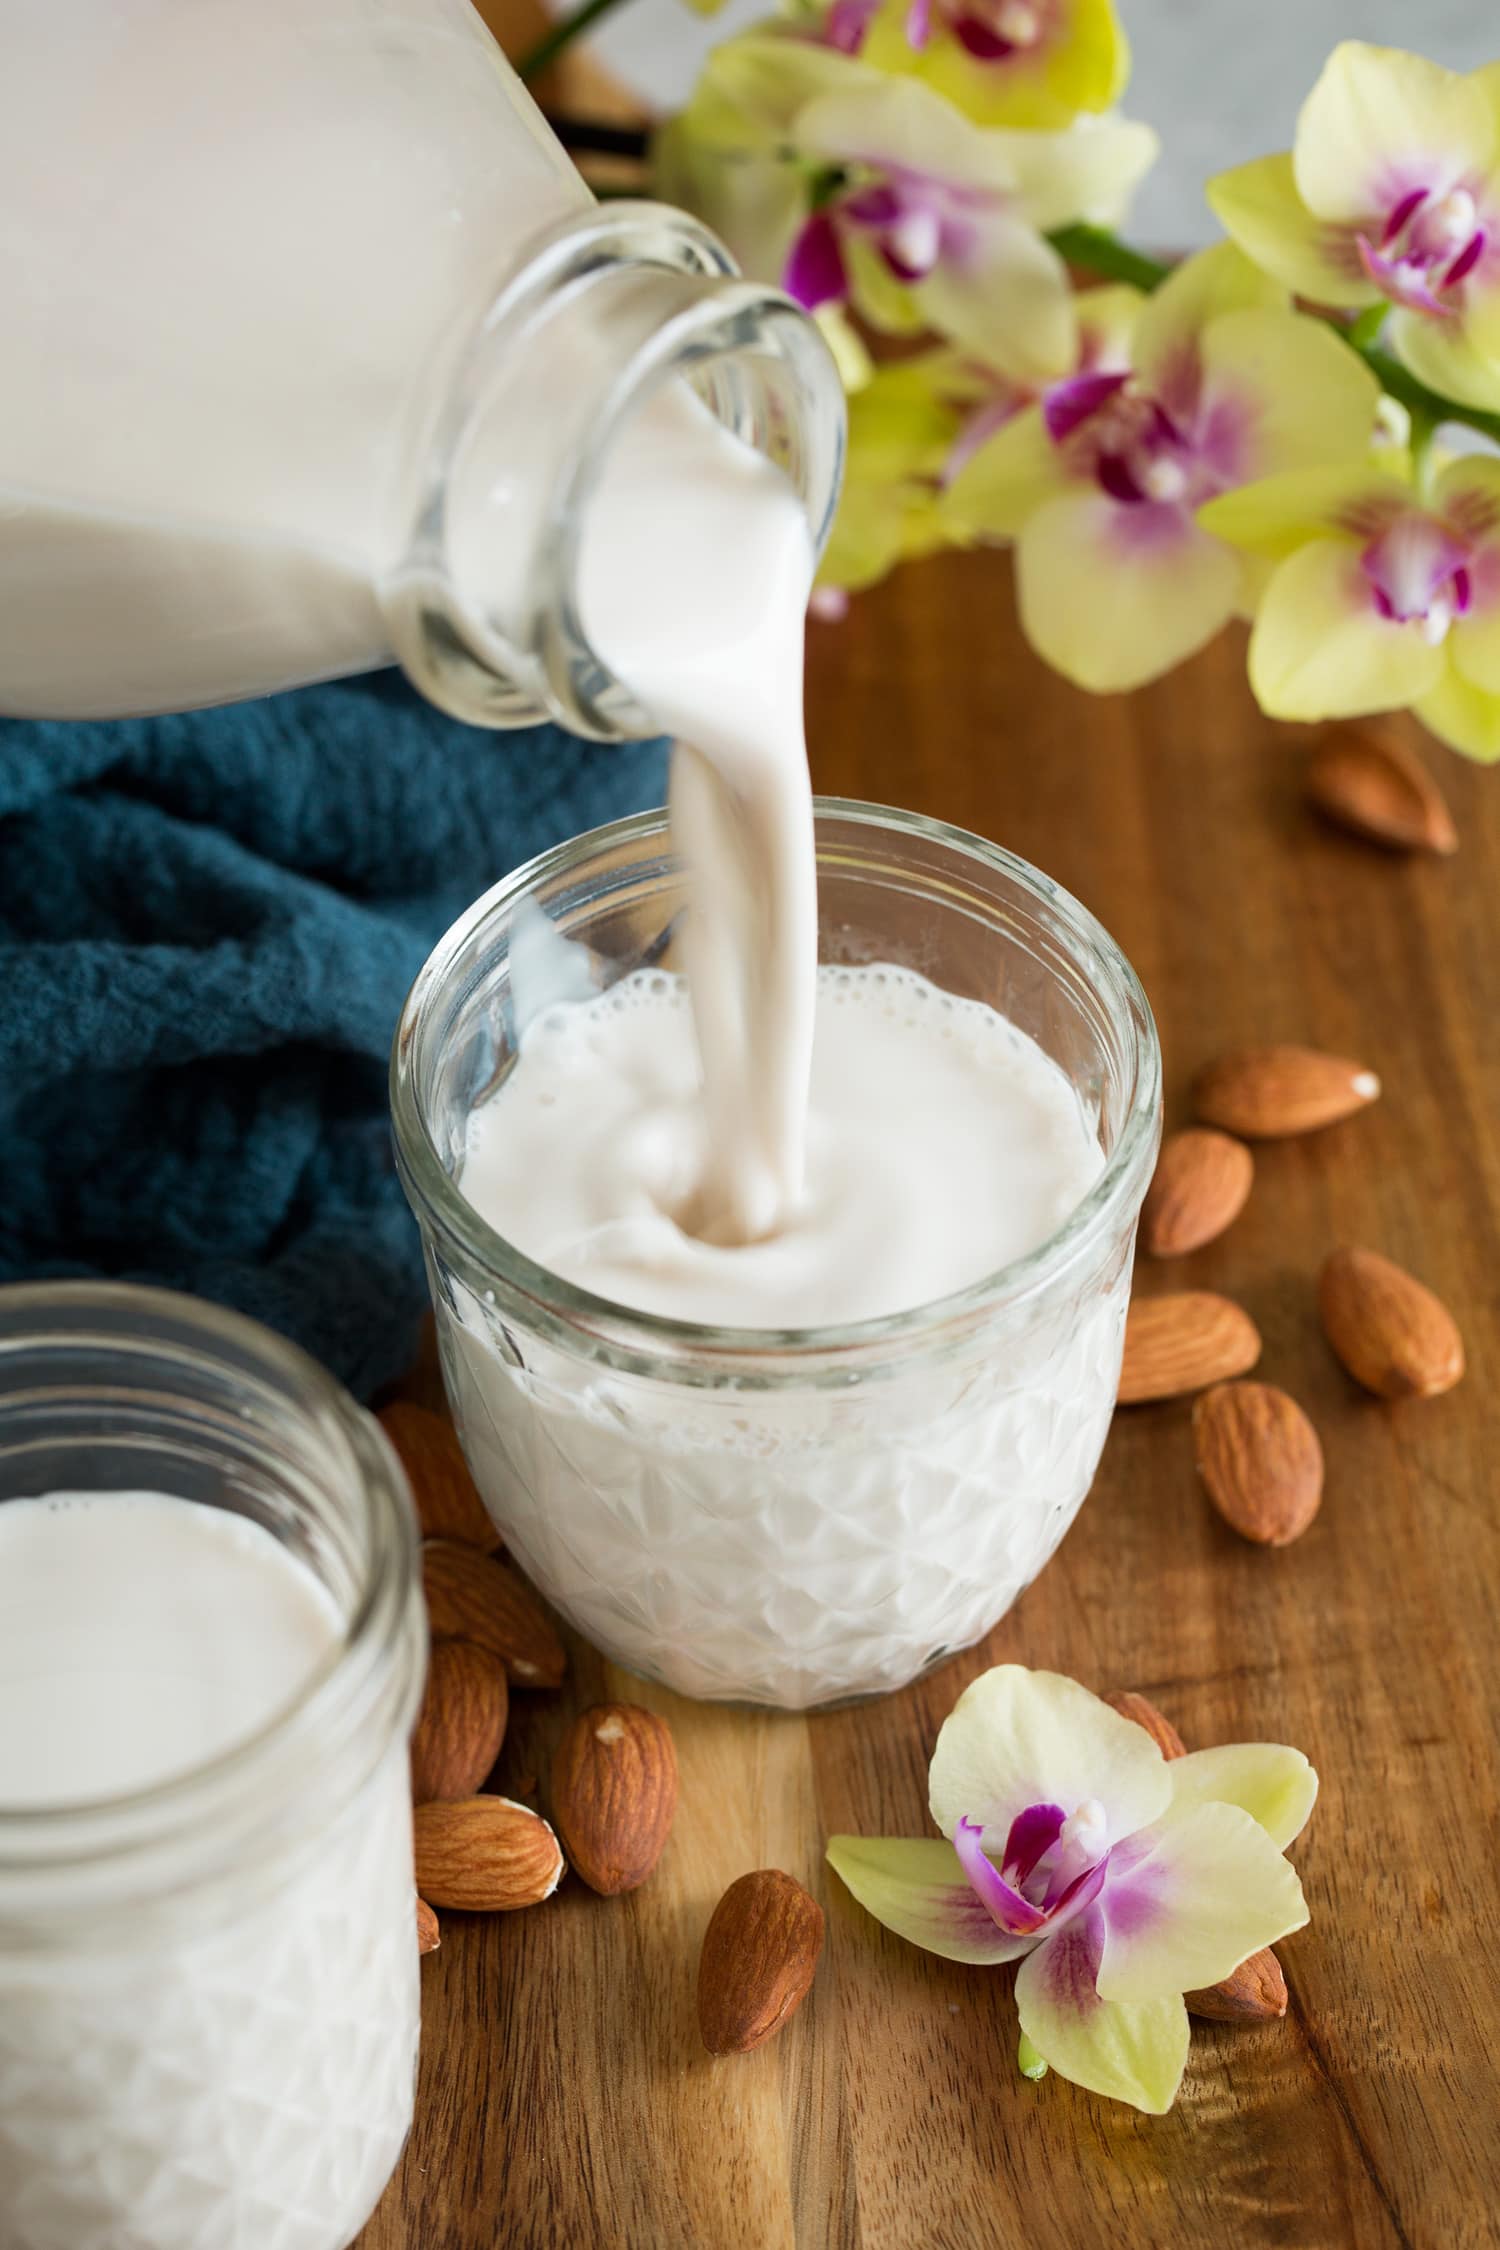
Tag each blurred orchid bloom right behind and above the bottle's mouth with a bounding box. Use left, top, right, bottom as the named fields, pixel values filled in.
left=657, top=32, right=1156, bottom=376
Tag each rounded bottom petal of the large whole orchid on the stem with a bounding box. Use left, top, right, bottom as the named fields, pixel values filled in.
left=1016, top=488, right=1241, bottom=693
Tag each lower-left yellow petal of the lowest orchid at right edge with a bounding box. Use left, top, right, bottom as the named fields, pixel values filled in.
left=1250, top=537, right=1446, bottom=720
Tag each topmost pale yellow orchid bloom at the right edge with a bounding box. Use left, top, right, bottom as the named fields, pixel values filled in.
left=1208, top=41, right=1500, bottom=407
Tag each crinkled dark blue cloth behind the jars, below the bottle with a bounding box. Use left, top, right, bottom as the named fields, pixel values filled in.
left=0, top=673, right=666, bottom=1397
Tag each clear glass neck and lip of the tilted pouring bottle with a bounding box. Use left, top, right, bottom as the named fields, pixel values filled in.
left=380, top=203, right=846, bottom=740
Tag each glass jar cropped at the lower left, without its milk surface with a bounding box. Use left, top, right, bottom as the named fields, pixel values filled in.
left=0, top=1283, right=425, bottom=2250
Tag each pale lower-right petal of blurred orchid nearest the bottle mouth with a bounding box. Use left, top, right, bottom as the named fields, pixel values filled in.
left=911, top=212, right=1077, bottom=387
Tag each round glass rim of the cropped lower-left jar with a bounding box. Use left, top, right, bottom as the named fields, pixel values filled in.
left=0, top=1280, right=418, bottom=1883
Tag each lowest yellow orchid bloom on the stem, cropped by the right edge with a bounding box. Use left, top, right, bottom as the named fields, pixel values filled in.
left=1203, top=455, right=1500, bottom=761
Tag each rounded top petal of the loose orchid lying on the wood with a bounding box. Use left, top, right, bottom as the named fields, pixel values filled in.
left=931, top=1665, right=1172, bottom=1852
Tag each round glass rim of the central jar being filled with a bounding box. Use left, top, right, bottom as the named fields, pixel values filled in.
left=391, top=797, right=1160, bottom=1388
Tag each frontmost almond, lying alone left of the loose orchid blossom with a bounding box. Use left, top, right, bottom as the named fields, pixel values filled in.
left=697, top=1868, right=823, bottom=2054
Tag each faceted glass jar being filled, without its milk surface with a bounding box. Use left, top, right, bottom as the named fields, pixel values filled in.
left=391, top=799, right=1160, bottom=1708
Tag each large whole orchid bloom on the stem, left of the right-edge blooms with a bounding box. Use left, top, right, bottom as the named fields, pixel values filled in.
left=942, top=243, right=1381, bottom=693
